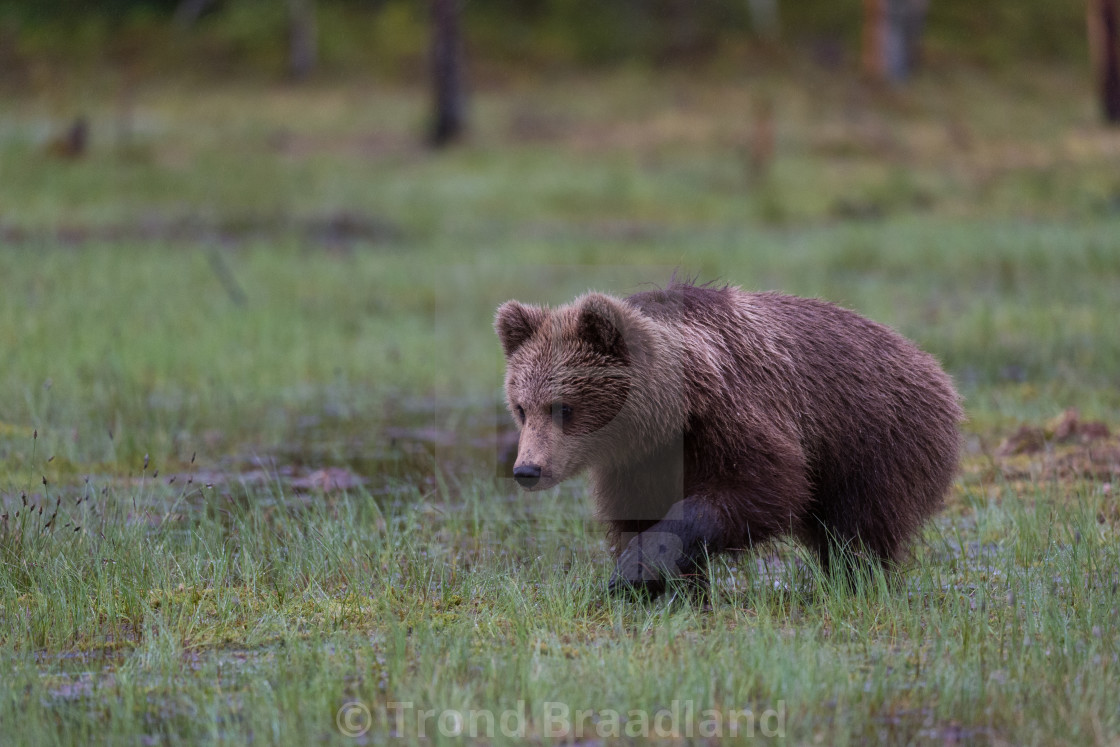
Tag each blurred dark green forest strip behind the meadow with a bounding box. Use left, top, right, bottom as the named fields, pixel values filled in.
left=0, top=0, right=1120, bottom=111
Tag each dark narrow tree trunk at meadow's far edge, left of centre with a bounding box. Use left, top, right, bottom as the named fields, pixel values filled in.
left=428, top=0, right=466, bottom=148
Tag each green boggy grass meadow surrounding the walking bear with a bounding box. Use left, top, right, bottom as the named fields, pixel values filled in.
left=0, top=62, right=1120, bottom=745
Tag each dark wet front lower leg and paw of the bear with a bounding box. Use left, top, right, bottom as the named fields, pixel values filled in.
left=608, top=497, right=726, bottom=597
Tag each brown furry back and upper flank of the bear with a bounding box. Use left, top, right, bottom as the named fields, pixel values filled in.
left=626, top=277, right=962, bottom=473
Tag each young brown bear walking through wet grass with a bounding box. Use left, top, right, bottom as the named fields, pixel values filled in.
left=494, top=280, right=962, bottom=594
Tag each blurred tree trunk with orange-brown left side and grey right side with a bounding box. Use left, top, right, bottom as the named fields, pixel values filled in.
left=862, top=0, right=930, bottom=83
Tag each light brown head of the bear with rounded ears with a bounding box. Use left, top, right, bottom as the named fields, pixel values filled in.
left=494, top=293, right=657, bottom=491
